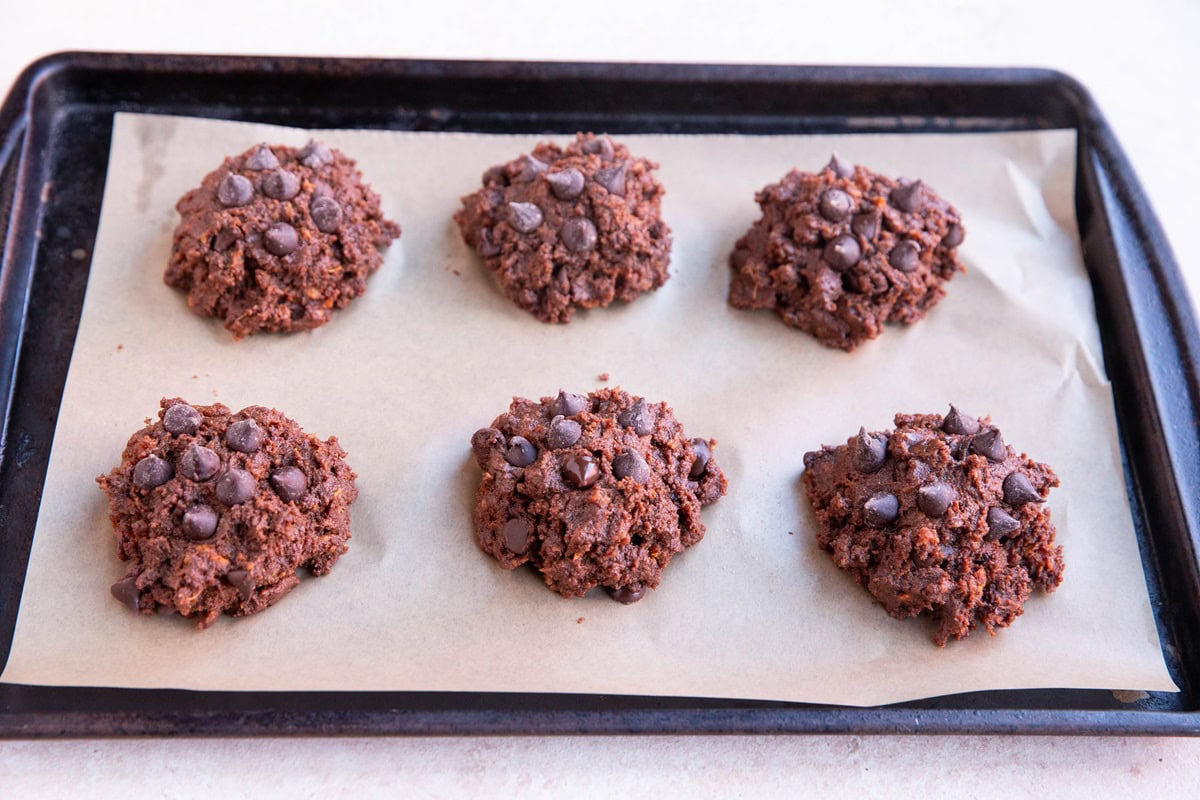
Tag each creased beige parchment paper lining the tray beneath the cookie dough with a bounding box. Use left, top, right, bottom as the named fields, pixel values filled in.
left=4, top=109, right=1175, bottom=705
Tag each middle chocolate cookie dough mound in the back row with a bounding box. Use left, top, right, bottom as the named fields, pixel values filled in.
left=455, top=133, right=671, bottom=323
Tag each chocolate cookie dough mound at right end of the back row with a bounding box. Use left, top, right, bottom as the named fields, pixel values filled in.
left=730, top=156, right=964, bottom=350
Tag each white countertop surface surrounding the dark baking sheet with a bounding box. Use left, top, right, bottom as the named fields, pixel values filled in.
left=0, top=0, right=1200, bottom=798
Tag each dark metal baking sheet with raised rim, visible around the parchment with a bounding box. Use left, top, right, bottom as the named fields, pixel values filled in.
left=0, top=53, right=1200, bottom=736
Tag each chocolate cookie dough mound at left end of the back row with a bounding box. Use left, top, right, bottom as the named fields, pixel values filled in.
left=164, top=142, right=400, bottom=338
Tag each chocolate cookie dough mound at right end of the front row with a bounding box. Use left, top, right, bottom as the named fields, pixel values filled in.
left=804, top=405, right=1063, bottom=645
